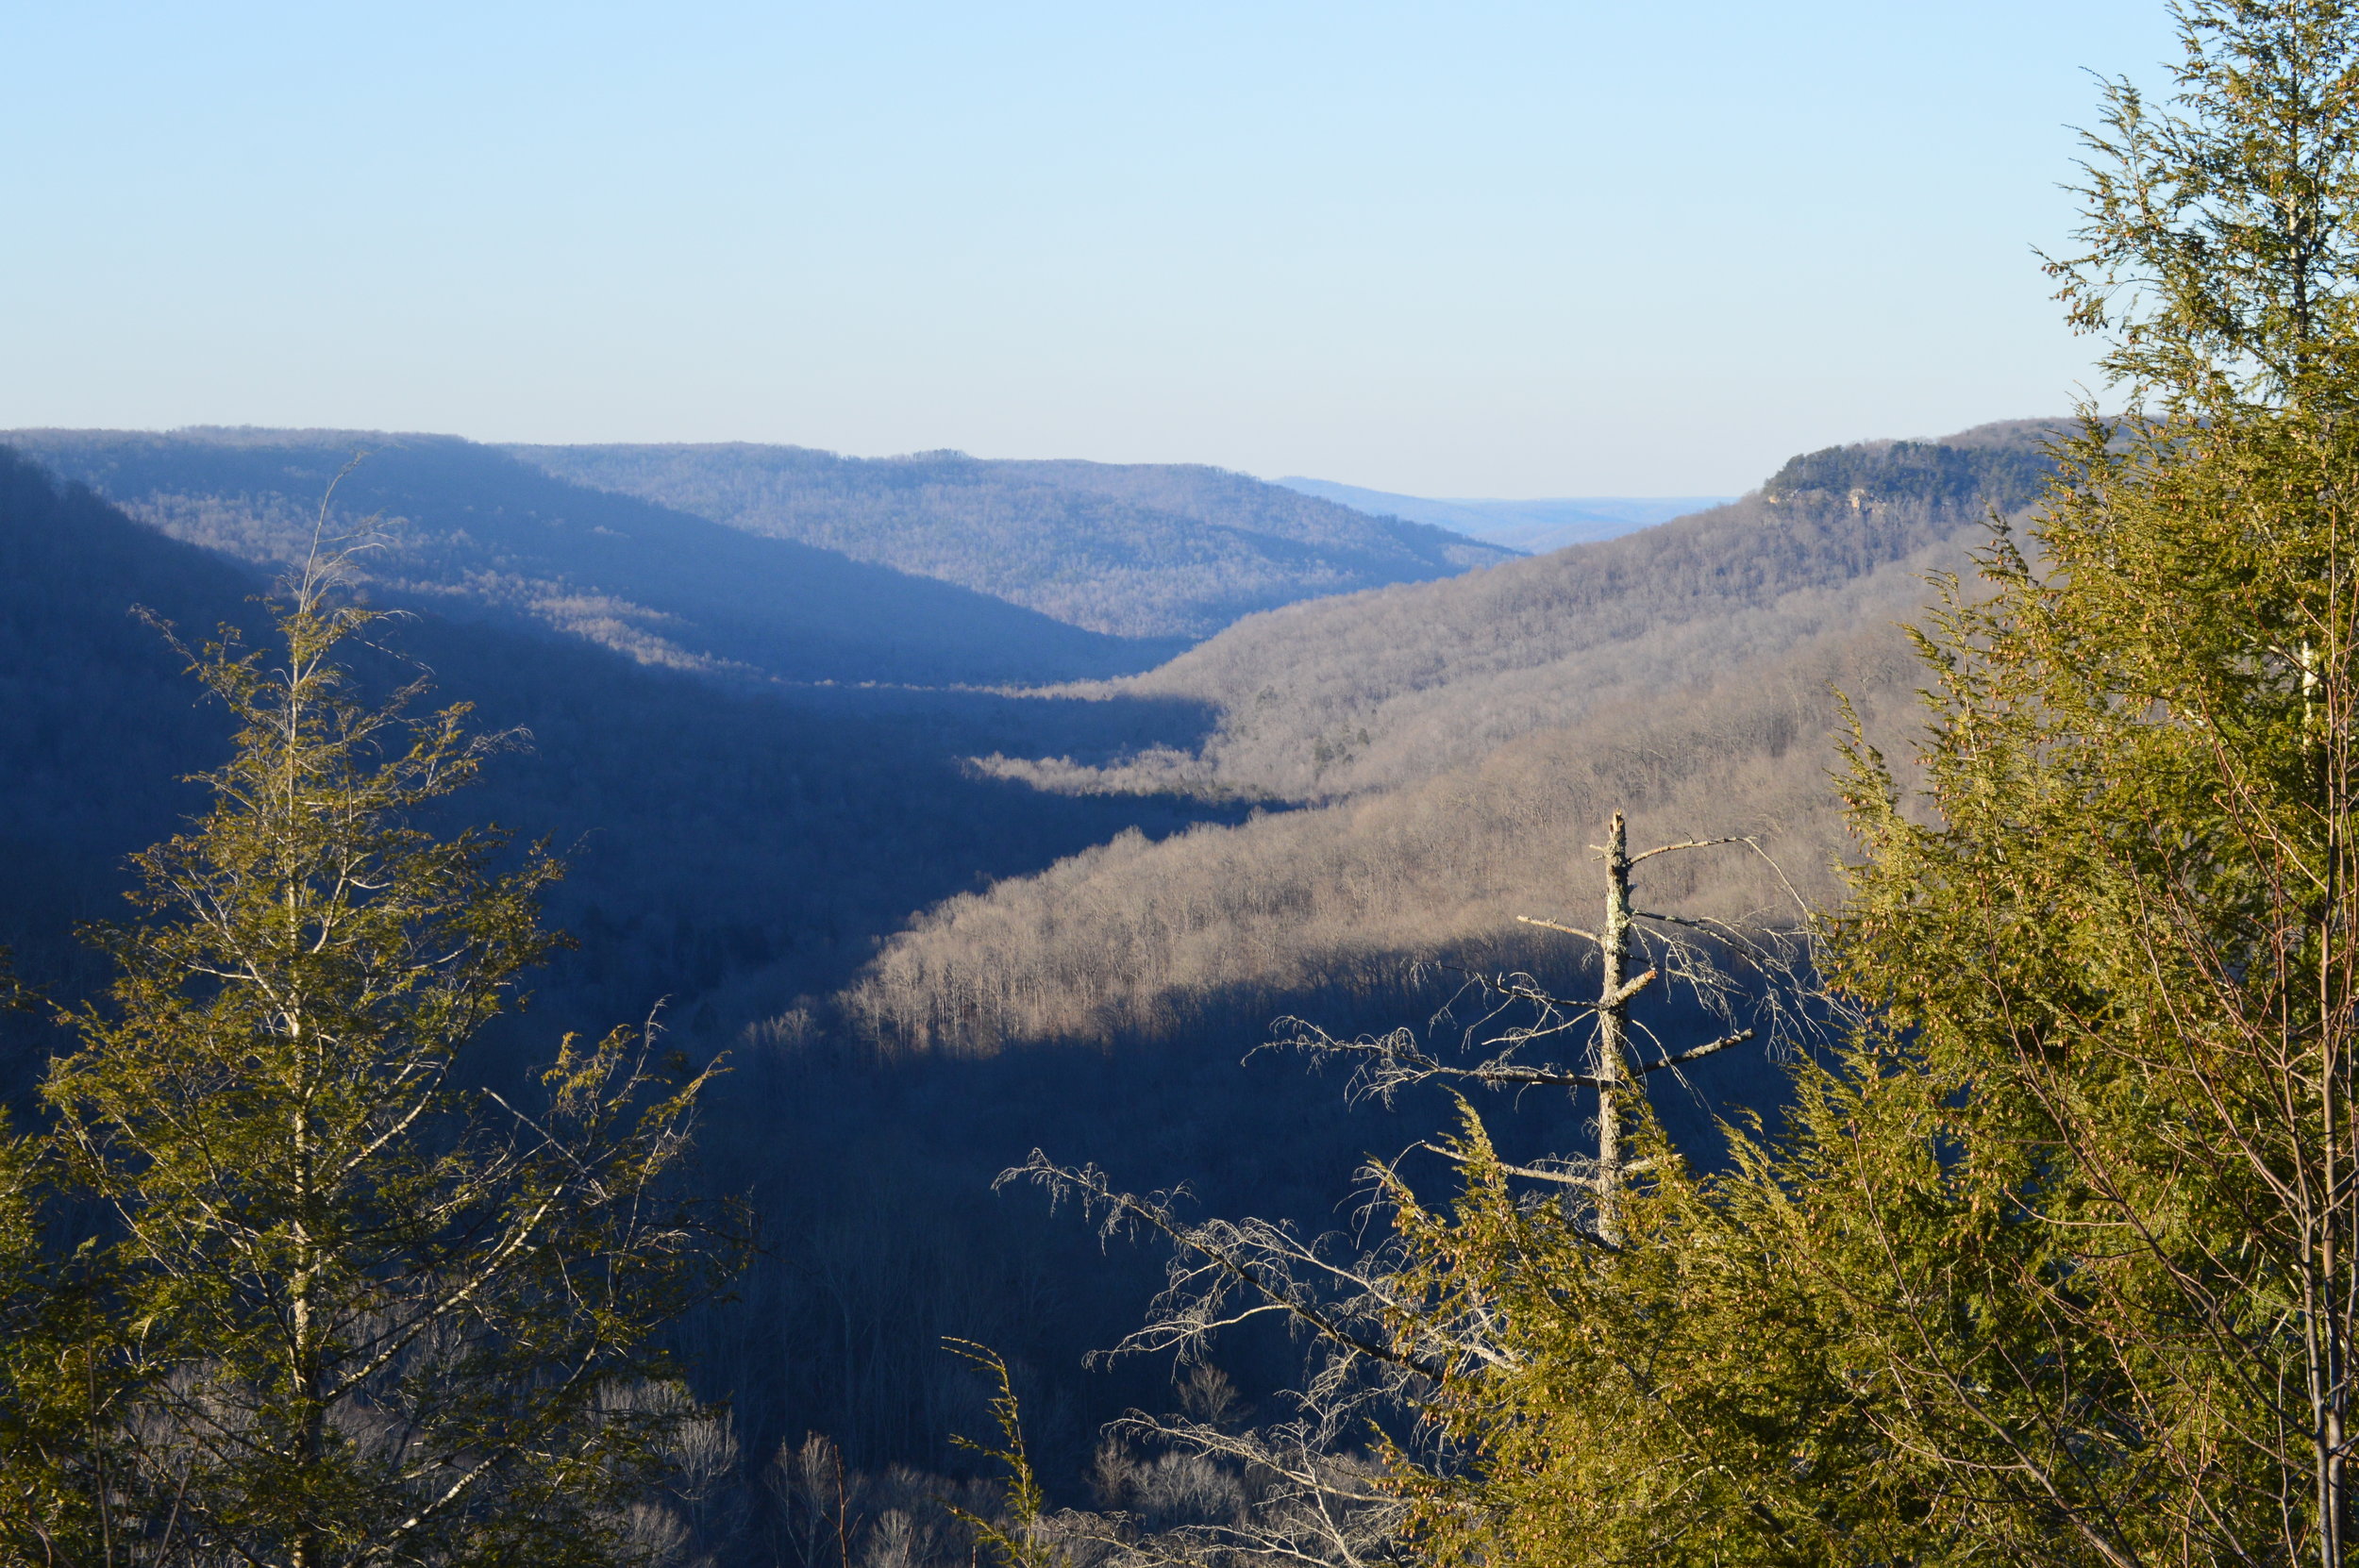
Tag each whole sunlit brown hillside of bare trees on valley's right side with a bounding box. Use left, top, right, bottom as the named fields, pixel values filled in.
left=845, top=419, right=2048, bottom=1052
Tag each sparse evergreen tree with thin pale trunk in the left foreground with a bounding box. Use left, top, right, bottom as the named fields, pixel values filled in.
left=39, top=557, right=734, bottom=1568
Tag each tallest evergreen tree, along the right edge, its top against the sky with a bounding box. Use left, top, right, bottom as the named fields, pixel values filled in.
left=1753, top=0, right=2359, bottom=1566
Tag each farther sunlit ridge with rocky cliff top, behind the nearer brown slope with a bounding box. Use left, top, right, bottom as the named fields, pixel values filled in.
left=994, top=420, right=2052, bottom=799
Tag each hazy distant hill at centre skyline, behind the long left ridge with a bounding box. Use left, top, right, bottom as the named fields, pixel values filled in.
left=508, top=445, right=1513, bottom=637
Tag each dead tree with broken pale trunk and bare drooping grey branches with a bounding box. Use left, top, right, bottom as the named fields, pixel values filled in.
left=1000, top=813, right=1816, bottom=1568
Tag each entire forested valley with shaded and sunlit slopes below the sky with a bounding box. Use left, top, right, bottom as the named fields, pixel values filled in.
left=0, top=422, right=2046, bottom=1518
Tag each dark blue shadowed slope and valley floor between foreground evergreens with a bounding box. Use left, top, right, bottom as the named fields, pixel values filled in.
left=0, top=445, right=1500, bottom=1488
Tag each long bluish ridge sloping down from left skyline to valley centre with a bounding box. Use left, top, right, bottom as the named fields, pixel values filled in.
left=8, top=429, right=1175, bottom=684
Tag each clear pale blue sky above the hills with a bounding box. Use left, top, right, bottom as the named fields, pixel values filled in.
left=0, top=0, right=2173, bottom=495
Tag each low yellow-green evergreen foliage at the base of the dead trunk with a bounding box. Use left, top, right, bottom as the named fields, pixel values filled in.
left=1390, top=1096, right=1939, bottom=1568
